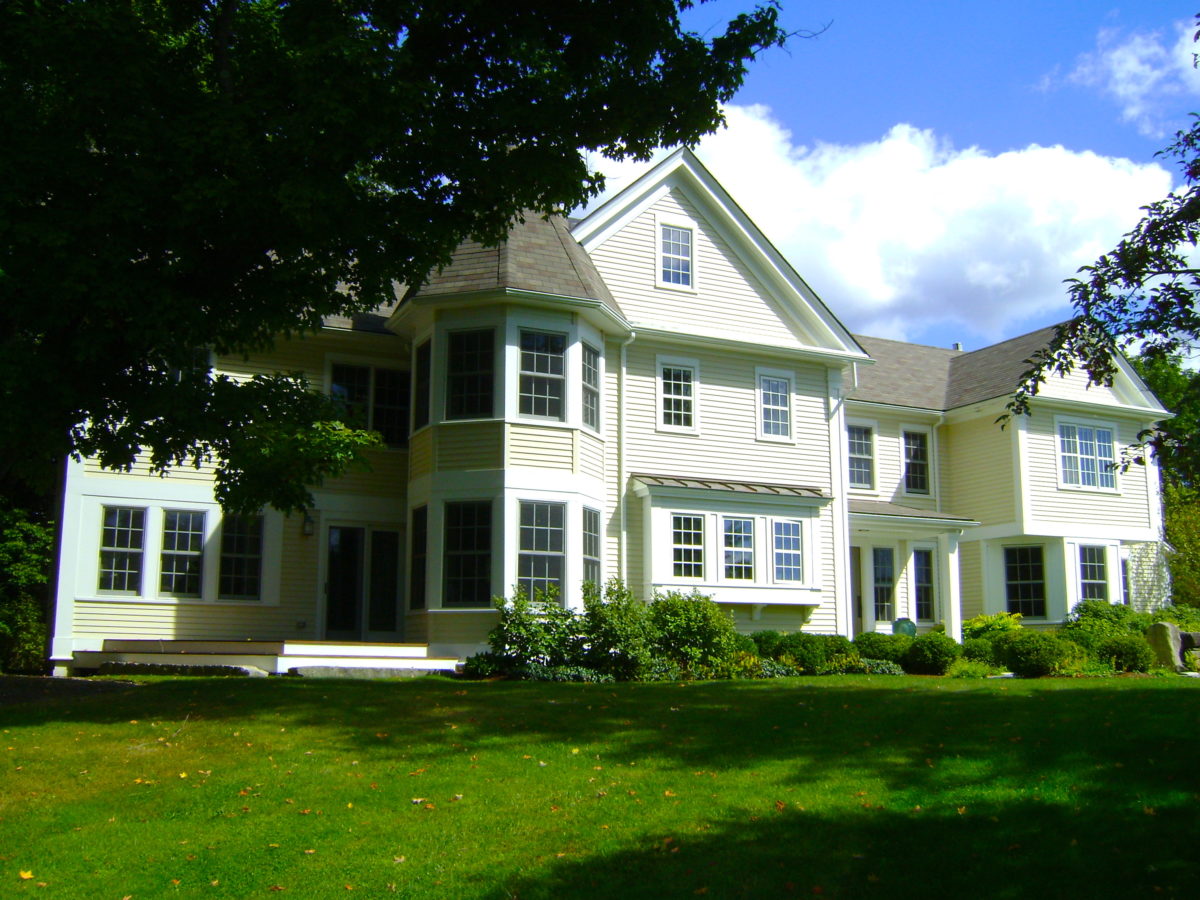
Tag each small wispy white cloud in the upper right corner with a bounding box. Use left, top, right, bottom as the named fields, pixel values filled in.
left=1067, top=22, right=1200, bottom=138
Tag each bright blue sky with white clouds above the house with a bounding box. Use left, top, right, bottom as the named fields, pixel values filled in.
left=585, top=0, right=1200, bottom=349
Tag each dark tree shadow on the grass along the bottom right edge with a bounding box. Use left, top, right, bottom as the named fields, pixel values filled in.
left=484, top=804, right=1196, bottom=900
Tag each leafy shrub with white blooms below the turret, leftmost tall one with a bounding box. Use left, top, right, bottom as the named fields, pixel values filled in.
left=487, top=590, right=583, bottom=670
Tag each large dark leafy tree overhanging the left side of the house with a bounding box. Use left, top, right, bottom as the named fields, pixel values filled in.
left=0, top=0, right=784, bottom=509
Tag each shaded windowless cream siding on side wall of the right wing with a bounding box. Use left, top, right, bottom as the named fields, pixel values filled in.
left=941, top=416, right=1018, bottom=526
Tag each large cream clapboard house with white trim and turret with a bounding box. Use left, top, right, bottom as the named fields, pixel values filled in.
left=52, top=150, right=1163, bottom=671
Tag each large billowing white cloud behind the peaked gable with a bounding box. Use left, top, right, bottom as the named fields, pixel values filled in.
left=585, top=106, right=1171, bottom=347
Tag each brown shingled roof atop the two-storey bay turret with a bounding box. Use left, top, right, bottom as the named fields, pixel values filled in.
left=406, top=212, right=622, bottom=316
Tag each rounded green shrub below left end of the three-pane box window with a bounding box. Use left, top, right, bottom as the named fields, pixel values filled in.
left=650, top=590, right=738, bottom=674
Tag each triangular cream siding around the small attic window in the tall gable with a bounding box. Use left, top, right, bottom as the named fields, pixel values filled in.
left=592, top=191, right=816, bottom=347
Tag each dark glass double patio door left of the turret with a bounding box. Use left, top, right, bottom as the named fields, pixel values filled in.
left=325, top=526, right=402, bottom=642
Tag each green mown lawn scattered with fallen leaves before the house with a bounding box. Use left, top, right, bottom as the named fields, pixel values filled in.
left=0, top=677, right=1200, bottom=900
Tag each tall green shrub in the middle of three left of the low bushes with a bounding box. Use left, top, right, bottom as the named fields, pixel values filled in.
left=582, top=578, right=655, bottom=680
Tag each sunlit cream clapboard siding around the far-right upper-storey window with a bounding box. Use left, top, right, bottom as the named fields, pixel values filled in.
left=1024, top=409, right=1153, bottom=529
